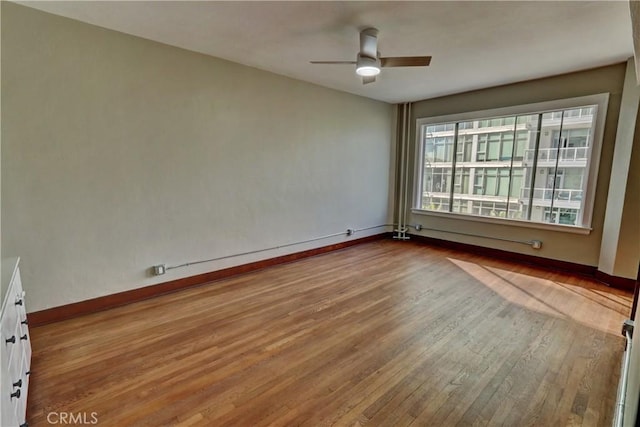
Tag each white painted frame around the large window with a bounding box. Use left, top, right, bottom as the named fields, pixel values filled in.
left=411, top=93, right=609, bottom=234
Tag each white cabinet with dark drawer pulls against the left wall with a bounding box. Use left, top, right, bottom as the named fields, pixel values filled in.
left=0, top=258, right=31, bottom=427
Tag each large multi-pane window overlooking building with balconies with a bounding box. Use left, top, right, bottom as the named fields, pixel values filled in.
left=414, top=94, right=608, bottom=228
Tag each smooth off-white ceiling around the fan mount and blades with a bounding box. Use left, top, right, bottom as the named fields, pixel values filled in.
left=19, top=1, right=633, bottom=103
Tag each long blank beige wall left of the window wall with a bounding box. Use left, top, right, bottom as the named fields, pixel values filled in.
left=2, top=2, right=394, bottom=311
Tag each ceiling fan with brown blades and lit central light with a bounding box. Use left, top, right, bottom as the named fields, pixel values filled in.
left=310, top=28, right=431, bottom=84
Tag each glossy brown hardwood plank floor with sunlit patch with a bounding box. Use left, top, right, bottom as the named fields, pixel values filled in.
left=28, top=241, right=631, bottom=426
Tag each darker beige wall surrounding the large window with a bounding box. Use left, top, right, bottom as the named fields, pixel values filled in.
left=408, top=63, right=640, bottom=270
